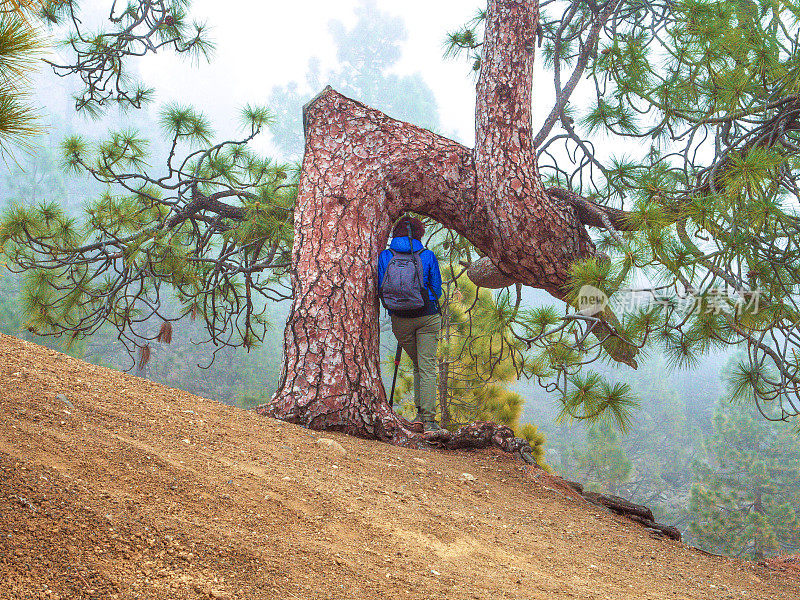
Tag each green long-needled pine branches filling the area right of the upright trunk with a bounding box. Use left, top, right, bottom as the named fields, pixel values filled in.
left=446, top=0, right=800, bottom=425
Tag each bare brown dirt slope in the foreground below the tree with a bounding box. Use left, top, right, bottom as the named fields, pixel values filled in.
left=0, top=336, right=800, bottom=600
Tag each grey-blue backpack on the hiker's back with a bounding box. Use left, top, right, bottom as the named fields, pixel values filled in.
left=379, top=225, right=430, bottom=317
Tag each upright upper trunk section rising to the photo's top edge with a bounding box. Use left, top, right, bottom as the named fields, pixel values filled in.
left=476, top=0, right=594, bottom=298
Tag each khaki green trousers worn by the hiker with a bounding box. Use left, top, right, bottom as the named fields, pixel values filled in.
left=392, top=314, right=442, bottom=421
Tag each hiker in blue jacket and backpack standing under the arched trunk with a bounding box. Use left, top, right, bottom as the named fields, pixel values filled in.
left=378, top=216, right=442, bottom=431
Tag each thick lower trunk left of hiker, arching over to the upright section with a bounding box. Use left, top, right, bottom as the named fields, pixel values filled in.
left=259, top=88, right=486, bottom=441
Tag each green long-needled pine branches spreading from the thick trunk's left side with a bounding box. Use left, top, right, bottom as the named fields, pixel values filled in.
left=0, top=105, right=296, bottom=354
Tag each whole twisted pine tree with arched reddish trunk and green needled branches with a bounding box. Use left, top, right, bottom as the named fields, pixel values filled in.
left=0, top=0, right=800, bottom=448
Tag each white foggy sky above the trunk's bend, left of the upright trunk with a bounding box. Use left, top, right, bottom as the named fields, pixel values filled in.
left=115, top=0, right=485, bottom=150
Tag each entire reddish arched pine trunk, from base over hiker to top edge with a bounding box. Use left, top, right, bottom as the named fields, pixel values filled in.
left=258, top=0, right=594, bottom=446
